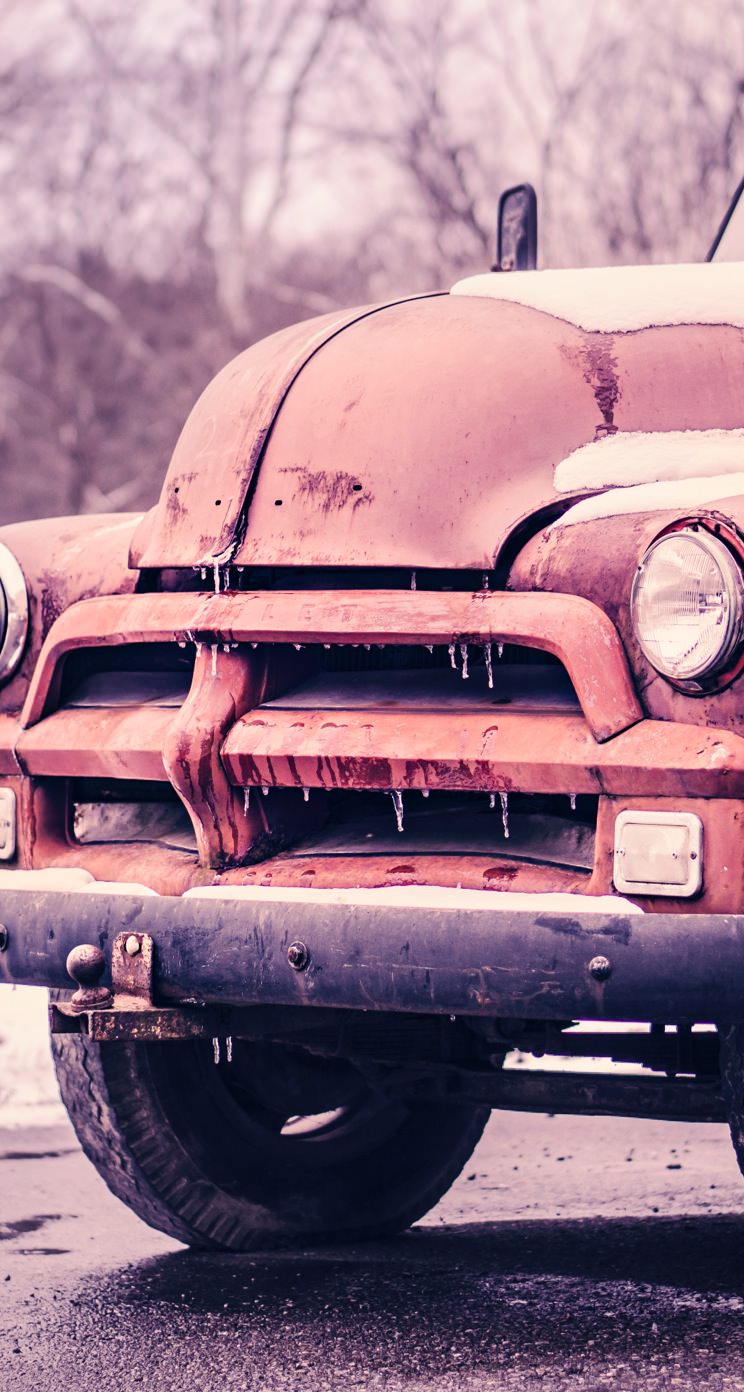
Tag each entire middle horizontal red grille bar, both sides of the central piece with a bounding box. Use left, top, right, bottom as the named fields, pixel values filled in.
left=13, top=701, right=744, bottom=801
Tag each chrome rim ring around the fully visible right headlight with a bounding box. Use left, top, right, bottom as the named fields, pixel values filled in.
left=630, top=522, right=744, bottom=695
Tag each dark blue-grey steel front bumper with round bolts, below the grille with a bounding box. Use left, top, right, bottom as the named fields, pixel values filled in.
left=0, top=889, right=744, bottom=1023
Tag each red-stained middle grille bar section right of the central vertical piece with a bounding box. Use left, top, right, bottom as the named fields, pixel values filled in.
left=223, top=707, right=744, bottom=798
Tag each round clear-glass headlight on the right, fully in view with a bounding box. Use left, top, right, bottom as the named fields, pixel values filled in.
left=630, top=530, right=744, bottom=682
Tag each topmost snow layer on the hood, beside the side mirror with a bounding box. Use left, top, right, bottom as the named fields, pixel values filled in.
left=450, top=262, right=744, bottom=333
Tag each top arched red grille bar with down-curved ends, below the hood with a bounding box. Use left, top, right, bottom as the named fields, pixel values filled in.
left=22, top=590, right=642, bottom=741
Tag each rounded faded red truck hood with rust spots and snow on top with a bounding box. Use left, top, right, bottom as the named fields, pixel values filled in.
left=131, top=264, right=744, bottom=569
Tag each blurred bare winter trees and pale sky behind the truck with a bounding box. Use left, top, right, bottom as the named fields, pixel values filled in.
left=0, top=0, right=744, bottom=521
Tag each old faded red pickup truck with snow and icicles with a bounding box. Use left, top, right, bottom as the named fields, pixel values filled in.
left=0, top=191, right=744, bottom=1250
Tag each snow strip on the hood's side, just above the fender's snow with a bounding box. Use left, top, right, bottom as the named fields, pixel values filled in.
left=553, top=430, right=744, bottom=493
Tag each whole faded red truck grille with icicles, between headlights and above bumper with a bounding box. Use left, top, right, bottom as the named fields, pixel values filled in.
left=18, top=592, right=638, bottom=883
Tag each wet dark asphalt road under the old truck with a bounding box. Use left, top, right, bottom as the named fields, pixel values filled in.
left=0, top=1114, right=744, bottom=1392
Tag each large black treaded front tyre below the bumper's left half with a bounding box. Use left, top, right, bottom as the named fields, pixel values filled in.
left=52, top=1013, right=489, bottom=1251
